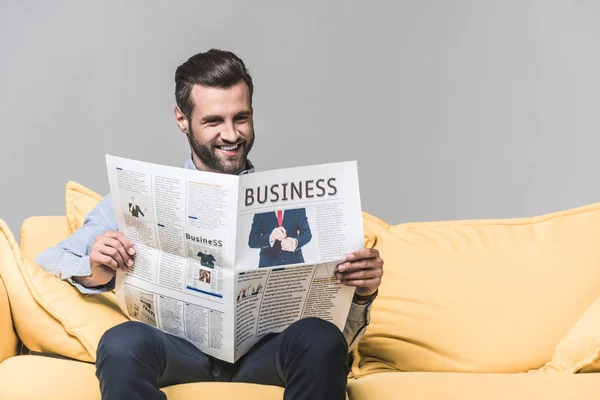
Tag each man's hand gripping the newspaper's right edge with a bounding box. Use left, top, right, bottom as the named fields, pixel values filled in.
left=335, top=249, right=383, bottom=296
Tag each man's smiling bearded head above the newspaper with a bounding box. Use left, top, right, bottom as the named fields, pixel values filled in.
left=175, top=56, right=254, bottom=174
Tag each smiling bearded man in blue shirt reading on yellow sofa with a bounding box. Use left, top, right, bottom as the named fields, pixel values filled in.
left=36, top=50, right=383, bottom=400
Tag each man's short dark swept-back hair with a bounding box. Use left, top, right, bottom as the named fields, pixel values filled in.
left=175, top=49, right=254, bottom=120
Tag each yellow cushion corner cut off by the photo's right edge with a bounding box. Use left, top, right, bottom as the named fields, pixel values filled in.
left=531, top=297, right=600, bottom=373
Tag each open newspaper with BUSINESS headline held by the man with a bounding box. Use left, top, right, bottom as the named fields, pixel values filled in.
left=106, top=155, right=364, bottom=362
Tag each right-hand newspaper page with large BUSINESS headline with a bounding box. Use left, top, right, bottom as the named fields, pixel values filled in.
left=235, top=162, right=364, bottom=356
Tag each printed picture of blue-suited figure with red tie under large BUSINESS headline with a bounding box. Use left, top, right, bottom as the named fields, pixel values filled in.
left=248, top=208, right=312, bottom=268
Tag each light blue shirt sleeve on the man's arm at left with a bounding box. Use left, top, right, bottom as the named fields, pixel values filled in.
left=35, top=195, right=118, bottom=294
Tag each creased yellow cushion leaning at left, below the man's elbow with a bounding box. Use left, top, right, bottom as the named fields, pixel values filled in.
left=0, top=217, right=127, bottom=362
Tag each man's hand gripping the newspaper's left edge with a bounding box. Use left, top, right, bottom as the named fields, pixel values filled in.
left=74, top=231, right=135, bottom=287
